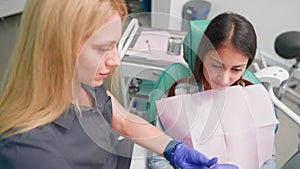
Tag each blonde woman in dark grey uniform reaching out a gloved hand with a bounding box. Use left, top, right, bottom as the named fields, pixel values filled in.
left=0, top=0, right=236, bottom=169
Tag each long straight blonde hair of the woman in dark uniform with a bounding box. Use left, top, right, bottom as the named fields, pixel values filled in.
left=0, top=0, right=127, bottom=138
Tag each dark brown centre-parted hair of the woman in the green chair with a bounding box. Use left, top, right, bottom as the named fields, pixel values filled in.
left=193, top=12, right=257, bottom=82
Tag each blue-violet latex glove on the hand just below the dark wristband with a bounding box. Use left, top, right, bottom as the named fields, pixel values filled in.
left=171, top=143, right=218, bottom=169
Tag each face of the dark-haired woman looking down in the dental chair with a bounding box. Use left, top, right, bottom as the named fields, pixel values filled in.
left=203, top=46, right=249, bottom=89
